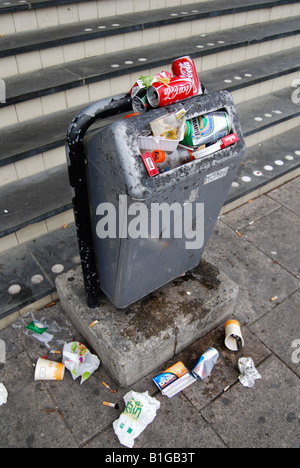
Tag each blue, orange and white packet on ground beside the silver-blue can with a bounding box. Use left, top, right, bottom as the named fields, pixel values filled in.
left=153, top=361, right=197, bottom=398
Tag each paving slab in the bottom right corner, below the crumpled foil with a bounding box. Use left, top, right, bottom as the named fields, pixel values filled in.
left=202, top=356, right=299, bottom=448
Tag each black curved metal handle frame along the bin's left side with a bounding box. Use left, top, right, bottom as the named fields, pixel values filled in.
left=66, top=94, right=132, bottom=309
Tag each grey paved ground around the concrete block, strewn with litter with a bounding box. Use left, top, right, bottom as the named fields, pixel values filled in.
left=0, top=177, right=300, bottom=450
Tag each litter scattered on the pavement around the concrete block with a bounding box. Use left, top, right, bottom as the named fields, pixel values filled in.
left=0, top=312, right=261, bottom=448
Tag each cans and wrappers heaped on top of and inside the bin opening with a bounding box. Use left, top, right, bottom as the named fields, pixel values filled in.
left=130, top=56, right=239, bottom=177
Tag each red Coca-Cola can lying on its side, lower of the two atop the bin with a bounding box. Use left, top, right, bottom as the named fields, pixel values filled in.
left=147, top=77, right=194, bottom=107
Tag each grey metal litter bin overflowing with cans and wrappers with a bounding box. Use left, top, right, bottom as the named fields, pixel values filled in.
left=67, top=58, right=245, bottom=309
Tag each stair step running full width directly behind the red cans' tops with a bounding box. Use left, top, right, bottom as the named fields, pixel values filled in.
left=0, top=12, right=300, bottom=132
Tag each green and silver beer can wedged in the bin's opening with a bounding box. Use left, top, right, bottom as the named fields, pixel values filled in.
left=182, top=111, right=231, bottom=147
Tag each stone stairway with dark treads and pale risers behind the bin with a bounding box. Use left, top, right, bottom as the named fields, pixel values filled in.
left=0, top=0, right=300, bottom=328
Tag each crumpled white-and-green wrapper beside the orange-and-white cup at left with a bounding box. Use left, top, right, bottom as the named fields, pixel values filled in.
left=62, top=341, right=100, bottom=384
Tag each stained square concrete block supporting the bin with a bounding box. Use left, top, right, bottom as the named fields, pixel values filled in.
left=56, top=260, right=238, bottom=387
